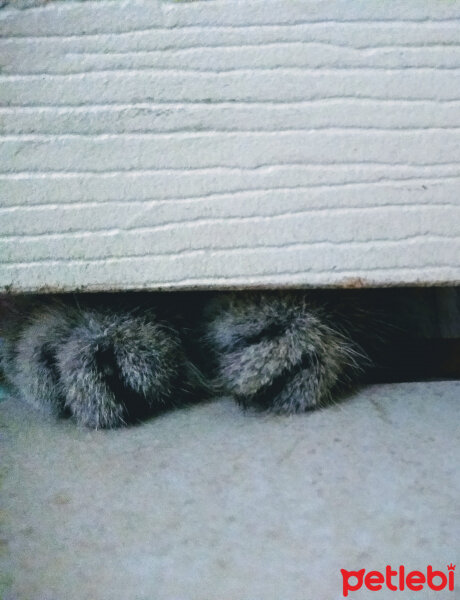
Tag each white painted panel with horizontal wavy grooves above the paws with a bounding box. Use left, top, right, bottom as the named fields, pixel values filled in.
left=0, top=0, right=460, bottom=291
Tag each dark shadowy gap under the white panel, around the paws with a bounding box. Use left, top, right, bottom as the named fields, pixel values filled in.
left=0, top=287, right=460, bottom=382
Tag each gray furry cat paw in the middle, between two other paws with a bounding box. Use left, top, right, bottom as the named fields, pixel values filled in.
left=57, top=310, right=186, bottom=429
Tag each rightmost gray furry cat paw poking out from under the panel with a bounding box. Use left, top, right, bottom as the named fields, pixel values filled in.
left=207, top=293, right=366, bottom=414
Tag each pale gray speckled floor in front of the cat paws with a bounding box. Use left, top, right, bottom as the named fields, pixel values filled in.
left=0, top=382, right=460, bottom=600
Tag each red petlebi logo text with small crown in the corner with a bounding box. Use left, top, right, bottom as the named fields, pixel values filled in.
left=340, top=563, right=455, bottom=598
